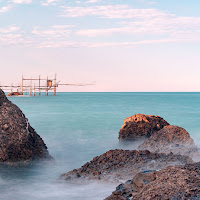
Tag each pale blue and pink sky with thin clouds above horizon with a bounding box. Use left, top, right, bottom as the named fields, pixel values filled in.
left=0, top=0, right=200, bottom=92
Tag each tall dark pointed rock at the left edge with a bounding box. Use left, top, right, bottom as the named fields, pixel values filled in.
left=0, top=89, right=53, bottom=165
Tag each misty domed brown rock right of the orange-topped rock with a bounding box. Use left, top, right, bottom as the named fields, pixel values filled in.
left=138, top=125, right=200, bottom=160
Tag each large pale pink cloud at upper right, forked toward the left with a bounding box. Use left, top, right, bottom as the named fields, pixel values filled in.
left=73, top=6, right=200, bottom=41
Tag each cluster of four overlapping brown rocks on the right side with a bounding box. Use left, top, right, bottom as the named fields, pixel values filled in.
left=60, top=114, right=200, bottom=200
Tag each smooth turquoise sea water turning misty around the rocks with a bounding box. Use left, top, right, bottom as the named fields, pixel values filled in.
left=0, top=93, right=200, bottom=200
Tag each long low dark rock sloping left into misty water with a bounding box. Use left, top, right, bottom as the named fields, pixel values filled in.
left=60, top=149, right=193, bottom=183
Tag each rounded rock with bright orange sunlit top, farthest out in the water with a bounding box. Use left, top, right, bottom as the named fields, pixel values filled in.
left=119, top=114, right=169, bottom=141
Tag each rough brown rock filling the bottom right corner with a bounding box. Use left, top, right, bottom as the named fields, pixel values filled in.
left=105, top=163, right=200, bottom=200
